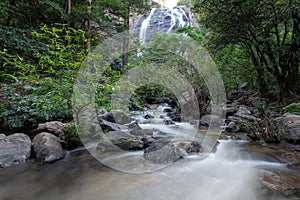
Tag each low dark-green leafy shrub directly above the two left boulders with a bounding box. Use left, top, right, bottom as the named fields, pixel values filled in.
left=0, top=91, right=72, bottom=131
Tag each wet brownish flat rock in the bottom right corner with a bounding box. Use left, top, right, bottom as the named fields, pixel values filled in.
left=260, top=170, right=300, bottom=197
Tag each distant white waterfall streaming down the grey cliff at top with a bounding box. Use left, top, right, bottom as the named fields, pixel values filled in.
left=135, top=6, right=190, bottom=44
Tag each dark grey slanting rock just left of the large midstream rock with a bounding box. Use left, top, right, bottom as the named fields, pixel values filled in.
left=107, top=131, right=144, bottom=151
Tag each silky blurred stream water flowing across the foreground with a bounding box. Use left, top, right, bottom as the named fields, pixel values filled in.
left=0, top=105, right=300, bottom=200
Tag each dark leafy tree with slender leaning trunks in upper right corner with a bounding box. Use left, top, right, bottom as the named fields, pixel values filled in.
left=193, top=0, right=300, bottom=100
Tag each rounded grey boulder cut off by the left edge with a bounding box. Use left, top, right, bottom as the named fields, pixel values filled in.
left=0, top=133, right=31, bottom=168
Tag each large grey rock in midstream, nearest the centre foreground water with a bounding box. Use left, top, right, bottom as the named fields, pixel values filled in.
left=144, top=138, right=202, bottom=163
